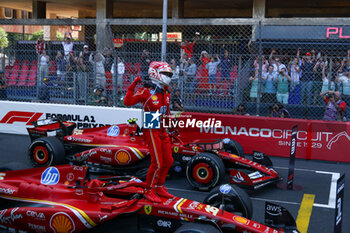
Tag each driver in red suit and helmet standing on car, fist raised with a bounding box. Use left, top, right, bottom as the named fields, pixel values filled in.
left=124, top=62, right=174, bottom=202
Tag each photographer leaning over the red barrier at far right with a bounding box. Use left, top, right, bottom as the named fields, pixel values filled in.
left=320, top=91, right=346, bottom=121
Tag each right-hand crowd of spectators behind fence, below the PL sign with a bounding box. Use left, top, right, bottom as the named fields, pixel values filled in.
left=249, top=49, right=350, bottom=119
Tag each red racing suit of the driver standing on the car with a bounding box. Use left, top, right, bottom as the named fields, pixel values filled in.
left=124, top=77, right=174, bottom=188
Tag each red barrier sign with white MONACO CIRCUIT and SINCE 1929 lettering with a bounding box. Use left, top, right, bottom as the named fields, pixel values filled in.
left=181, top=113, right=350, bottom=162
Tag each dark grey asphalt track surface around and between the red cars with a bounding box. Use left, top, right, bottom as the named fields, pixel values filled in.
left=0, top=134, right=350, bottom=233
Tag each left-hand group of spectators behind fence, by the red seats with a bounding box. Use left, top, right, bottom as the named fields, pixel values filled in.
left=31, top=32, right=130, bottom=104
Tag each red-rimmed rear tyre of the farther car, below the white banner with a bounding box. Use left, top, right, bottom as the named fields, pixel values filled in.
left=28, top=137, right=65, bottom=167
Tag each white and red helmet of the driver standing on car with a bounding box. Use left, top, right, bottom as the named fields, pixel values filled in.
left=148, top=61, right=173, bottom=86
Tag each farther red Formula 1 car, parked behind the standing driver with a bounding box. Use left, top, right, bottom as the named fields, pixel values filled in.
left=28, top=119, right=281, bottom=190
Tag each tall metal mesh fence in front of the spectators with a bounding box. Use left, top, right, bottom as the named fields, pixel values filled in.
left=0, top=22, right=350, bottom=119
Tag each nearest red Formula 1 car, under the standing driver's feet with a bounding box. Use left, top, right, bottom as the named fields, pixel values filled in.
left=0, top=165, right=298, bottom=233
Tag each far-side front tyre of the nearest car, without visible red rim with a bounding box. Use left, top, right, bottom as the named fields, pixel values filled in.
left=203, top=185, right=253, bottom=219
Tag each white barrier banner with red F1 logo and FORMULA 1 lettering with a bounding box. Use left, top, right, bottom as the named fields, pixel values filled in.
left=0, top=101, right=141, bottom=134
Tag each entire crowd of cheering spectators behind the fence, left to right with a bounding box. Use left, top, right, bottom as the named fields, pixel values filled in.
left=4, top=33, right=350, bottom=122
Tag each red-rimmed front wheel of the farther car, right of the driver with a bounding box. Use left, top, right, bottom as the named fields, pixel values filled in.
left=186, top=153, right=225, bottom=191
